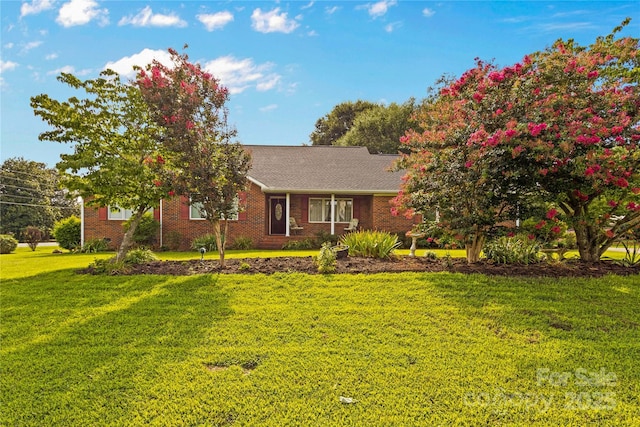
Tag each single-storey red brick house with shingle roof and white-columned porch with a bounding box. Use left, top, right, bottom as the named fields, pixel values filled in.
left=82, top=145, right=419, bottom=249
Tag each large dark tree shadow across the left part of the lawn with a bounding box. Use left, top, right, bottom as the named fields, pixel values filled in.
left=0, top=271, right=232, bottom=425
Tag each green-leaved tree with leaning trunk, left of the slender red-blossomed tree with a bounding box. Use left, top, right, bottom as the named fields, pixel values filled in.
left=31, top=70, right=172, bottom=261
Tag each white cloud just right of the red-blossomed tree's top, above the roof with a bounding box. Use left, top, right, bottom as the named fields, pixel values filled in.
left=203, top=56, right=280, bottom=94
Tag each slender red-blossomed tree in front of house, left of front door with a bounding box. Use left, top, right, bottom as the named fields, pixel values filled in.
left=137, top=49, right=250, bottom=267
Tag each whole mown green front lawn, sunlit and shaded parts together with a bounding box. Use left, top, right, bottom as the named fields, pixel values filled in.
left=0, top=252, right=640, bottom=426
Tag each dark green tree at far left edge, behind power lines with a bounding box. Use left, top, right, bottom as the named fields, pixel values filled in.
left=0, top=157, right=80, bottom=240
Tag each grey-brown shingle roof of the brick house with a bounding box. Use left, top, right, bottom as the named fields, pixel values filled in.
left=245, top=145, right=403, bottom=194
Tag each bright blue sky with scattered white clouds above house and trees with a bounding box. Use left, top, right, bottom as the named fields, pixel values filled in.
left=0, top=0, right=640, bottom=166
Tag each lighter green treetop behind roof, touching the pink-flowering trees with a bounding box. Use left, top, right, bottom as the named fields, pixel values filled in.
left=333, top=98, right=416, bottom=154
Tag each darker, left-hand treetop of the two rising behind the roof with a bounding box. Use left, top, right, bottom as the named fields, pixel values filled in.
left=309, top=100, right=377, bottom=145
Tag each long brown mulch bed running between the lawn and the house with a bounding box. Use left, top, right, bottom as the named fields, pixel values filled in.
left=81, top=256, right=640, bottom=277
